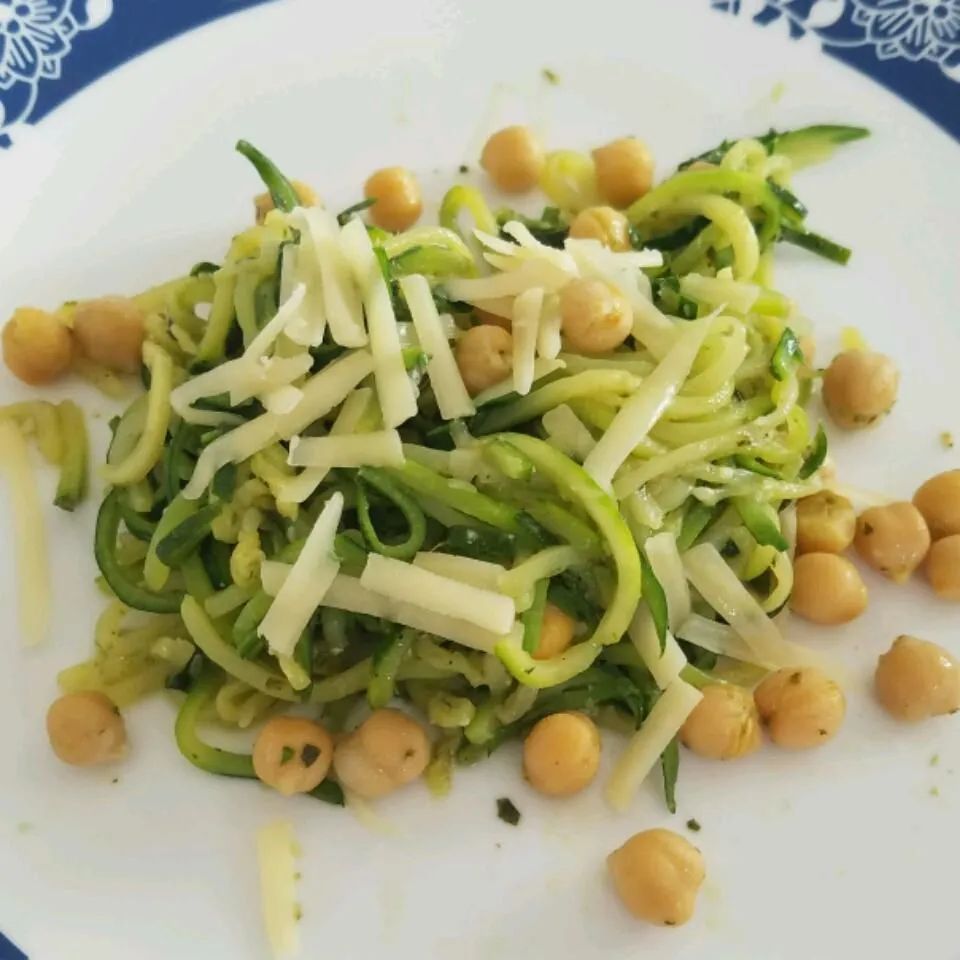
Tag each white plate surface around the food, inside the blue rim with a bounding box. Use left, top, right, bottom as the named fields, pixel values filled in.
left=0, top=0, right=960, bottom=960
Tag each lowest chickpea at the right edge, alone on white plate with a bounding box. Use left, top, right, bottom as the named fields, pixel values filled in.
left=874, top=636, right=960, bottom=723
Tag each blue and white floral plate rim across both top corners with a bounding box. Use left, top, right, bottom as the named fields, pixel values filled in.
left=0, top=0, right=960, bottom=149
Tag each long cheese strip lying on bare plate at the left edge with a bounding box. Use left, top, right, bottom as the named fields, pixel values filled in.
left=0, top=420, right=53, bottom=646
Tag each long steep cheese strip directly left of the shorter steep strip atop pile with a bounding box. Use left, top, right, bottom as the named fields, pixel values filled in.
left=340, top=218, right=417, bottom=427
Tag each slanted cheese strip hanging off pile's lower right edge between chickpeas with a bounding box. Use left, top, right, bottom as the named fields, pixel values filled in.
left=604, top=680, right=703, bottom=812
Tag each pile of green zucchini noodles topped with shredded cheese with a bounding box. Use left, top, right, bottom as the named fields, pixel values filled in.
left=37, top=120, right=866, bottom=808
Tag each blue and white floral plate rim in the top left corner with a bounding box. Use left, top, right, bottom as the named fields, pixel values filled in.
left=0, top=0, right=278, bottom=149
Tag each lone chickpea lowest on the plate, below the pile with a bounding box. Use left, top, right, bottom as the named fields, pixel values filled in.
left=607, top=829, right=706, bottom=927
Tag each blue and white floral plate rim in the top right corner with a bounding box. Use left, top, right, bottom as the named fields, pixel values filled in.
left=710, top=0, right=960, bottom=140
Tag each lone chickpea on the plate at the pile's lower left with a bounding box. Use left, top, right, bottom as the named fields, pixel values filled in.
left=47, top=691, right=127, bottom=767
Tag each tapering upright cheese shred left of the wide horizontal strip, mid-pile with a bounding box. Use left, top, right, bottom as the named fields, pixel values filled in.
left=258, top=491, right=343, bottom=657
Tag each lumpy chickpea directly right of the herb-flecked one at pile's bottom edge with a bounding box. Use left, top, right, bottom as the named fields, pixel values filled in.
left=333, top=707, right=430, bottom=800
